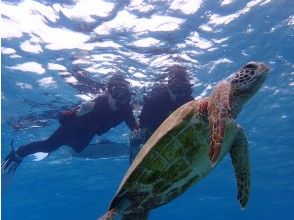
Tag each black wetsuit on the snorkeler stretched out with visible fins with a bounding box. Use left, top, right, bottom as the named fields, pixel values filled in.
left=16, top=95, right=136, bottom=157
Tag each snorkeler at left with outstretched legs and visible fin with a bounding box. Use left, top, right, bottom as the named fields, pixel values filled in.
left=1, top=75, right=137, bottom=173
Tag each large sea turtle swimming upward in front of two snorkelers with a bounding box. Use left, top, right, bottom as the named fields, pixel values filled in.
left=101, top=62, right=269, bottom=220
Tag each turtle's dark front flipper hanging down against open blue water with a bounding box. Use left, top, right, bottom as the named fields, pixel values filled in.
left=230, top=125, right=250, bottom=208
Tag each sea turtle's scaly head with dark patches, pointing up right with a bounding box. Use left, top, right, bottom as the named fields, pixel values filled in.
left=227, top=62, right=269, bottom=115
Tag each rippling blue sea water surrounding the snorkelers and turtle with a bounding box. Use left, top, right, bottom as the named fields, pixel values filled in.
left=1, top=0, right=294, bottom=220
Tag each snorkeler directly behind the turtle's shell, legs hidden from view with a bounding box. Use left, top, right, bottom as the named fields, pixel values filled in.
left=130, top=65, right=194, bottom=163
